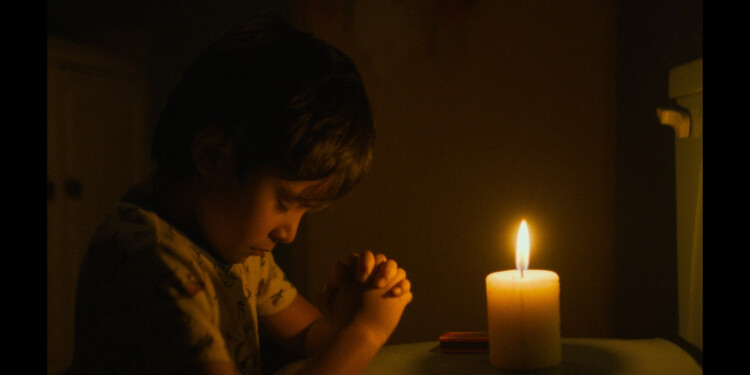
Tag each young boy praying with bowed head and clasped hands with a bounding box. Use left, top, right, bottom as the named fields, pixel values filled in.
left=71, top=17, right=412, bottom=375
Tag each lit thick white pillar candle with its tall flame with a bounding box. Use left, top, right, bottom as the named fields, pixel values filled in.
left=486, top=220, right=562, bottom=371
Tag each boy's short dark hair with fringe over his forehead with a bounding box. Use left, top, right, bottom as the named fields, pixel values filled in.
left=152, top=15, right=375, bottom=206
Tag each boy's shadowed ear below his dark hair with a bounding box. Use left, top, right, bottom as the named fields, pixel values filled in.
left=190, top=126, right=232, bottom=176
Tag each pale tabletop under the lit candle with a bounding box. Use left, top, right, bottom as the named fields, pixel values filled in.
left=363, top=338, right=703, bottom=375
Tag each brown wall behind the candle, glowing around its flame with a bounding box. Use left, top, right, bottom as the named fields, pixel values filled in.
left=296, top=0, right=616, bottom=343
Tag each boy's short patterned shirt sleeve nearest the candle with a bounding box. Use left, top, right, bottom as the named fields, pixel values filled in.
left=257, top=254, right=297, bottom=315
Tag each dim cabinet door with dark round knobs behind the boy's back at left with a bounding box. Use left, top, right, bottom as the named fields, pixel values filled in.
left=47, top=39, right=146, bottom=374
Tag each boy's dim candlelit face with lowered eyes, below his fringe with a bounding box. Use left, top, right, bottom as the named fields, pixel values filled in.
left=195, top=164, right=322, bottom=263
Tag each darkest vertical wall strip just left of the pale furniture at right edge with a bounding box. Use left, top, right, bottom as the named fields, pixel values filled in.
left=615, top=0, right=703, bottom=339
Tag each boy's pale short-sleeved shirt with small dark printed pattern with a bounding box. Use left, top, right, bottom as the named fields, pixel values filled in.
left=73, top=189, right=297, bottom=374
